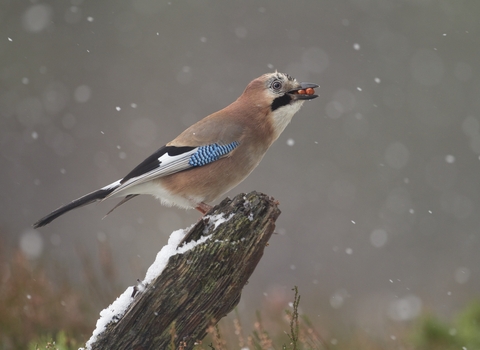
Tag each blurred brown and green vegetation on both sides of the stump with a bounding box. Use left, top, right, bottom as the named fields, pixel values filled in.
left=0, top=242, right=480, bottom=350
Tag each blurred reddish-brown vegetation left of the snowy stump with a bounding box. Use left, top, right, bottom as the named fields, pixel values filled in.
left=0, top=237, right=123, bottom=350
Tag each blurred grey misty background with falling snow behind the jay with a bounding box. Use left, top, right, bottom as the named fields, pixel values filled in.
left=0, top=0, right=480, bottom=334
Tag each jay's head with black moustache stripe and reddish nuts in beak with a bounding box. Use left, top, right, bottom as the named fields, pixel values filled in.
left=240, top=72, right=318, bottom=139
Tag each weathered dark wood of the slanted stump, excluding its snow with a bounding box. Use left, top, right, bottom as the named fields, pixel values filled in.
left=91, top=192, right=280, bottom=350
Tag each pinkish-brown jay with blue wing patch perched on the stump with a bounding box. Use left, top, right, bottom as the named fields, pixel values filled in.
left=33, top=72, right=319, bottom=228
